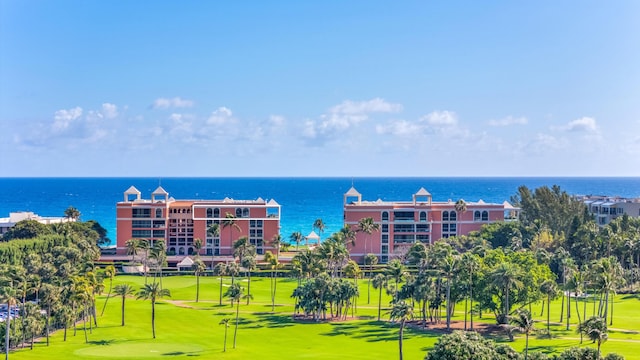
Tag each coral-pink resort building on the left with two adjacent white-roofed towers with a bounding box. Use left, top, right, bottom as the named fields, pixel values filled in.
left=116, top=186, right=280, bottom=262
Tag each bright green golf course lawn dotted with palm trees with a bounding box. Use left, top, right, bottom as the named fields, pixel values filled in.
left=10, top=276, right=640, bottom=360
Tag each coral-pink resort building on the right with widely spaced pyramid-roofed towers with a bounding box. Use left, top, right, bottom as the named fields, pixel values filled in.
left=344, top=187, right=519, bottom=262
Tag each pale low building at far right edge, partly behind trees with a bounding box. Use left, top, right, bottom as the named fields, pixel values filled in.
left=575, top=195, right=640, bottom=226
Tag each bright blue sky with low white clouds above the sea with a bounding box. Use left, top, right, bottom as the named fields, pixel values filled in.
left=0, top=0, right=640, bottom=177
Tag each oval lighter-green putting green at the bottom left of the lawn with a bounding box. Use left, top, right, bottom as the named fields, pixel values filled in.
left=73, top=342, right=203, bottom=359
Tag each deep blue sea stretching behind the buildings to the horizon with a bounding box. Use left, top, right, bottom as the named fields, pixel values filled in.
left=0, top=177, right=640, bottom=242
